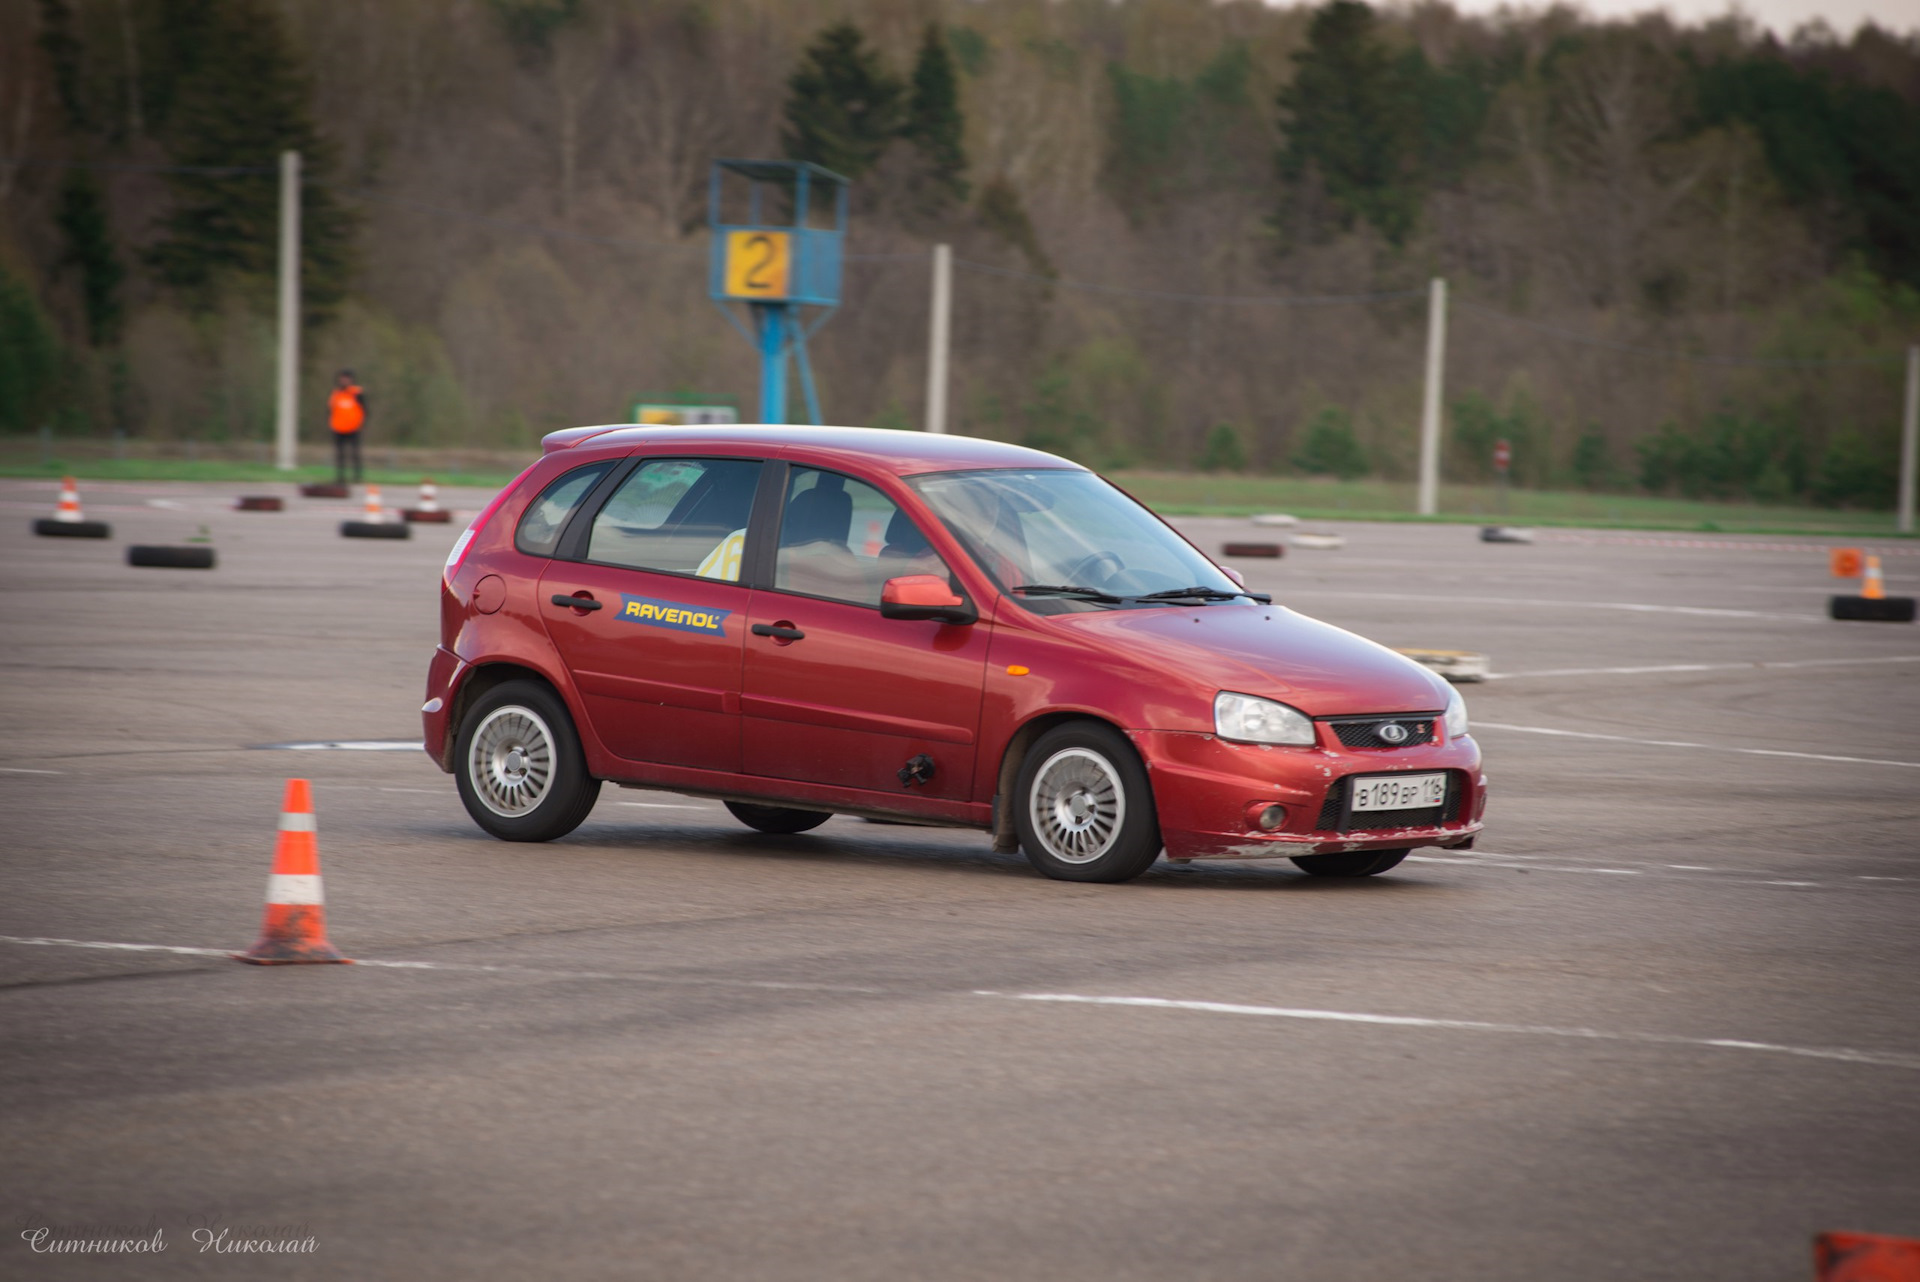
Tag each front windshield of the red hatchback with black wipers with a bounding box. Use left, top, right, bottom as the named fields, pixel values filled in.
left=908, top=468, right=1244, bottom=612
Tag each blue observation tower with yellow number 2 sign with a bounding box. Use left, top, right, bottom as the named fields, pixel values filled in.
left=707, top=159, right=849, bottom=422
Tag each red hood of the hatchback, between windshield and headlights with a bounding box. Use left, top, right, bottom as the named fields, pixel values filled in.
left=1054, top=605, right=1448, bottom=716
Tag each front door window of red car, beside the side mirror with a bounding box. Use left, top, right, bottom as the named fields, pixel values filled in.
left=774, top=466, right=947, bottom=606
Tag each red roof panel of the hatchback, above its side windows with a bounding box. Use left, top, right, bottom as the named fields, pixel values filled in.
left=541, top=422, right=1085, bottom=476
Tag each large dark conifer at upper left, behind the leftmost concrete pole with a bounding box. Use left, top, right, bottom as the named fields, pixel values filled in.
left=148, top=0, right=353, bottom=322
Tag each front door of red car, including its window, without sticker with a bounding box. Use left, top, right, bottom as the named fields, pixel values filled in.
left=741, top=466, right=989, bottom=800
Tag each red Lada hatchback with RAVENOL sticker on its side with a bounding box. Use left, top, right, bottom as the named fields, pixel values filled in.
left=422, top=426, right=1486, bottom=881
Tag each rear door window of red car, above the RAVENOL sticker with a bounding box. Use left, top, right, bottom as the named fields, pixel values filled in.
left=588, top=459, right=760, bottom=582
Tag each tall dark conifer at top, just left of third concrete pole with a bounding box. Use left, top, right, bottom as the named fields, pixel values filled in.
left=1279, top=0, right=1421, bottom=246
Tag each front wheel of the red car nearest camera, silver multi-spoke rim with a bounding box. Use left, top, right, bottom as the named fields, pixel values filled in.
left=1014, top=722, right=1160, bottom=881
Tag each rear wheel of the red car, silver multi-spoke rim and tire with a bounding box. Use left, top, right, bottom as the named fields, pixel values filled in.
left=453, top=681, right=599, bottom=841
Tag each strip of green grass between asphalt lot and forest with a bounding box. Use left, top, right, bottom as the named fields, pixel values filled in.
left=0, top=449, right=1903, bottom=537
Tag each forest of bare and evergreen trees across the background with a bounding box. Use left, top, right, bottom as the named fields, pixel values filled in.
left=0, top=0, right=1920, bottom=505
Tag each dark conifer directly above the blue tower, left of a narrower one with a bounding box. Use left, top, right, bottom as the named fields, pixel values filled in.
left=781, top=21, right=904, bottom=178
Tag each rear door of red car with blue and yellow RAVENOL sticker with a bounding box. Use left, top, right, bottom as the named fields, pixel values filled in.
left=540, top=457, right=762, bottom=772
